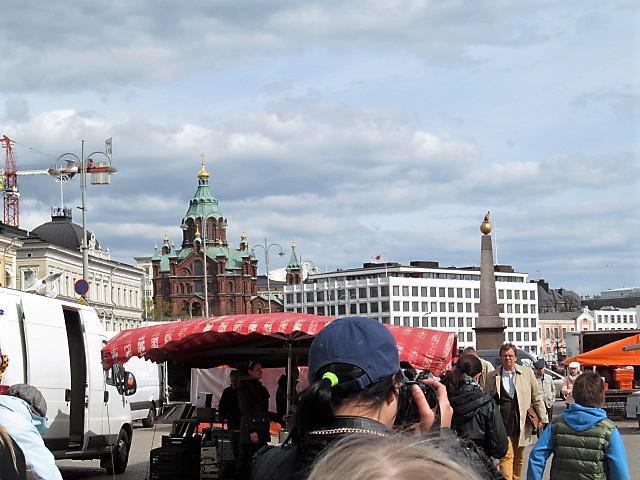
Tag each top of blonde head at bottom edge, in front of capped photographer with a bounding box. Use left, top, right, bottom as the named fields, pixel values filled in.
left=308, top=435, right=480, bottom=480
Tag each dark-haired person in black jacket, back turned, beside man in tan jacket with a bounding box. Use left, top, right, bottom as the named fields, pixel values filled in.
left=445, top=355, right=508, bottom=476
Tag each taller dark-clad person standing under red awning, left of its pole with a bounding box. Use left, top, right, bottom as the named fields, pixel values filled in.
left=236, top=361, right=270, bottom=480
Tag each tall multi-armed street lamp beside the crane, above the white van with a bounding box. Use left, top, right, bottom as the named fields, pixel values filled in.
left=56, top=140, right=117, bottom=288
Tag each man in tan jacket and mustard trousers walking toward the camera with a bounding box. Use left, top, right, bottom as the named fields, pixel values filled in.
left=485, top=343, right=549, bottom=480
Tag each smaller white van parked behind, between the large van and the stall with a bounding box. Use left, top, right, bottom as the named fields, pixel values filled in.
left=126, top=357, right=167, bottom=427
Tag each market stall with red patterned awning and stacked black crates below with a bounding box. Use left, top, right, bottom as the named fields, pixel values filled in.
left=102, top=312, right=457, bottom=480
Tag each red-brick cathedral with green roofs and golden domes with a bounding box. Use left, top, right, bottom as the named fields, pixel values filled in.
left=151, top=162, right=282, bottom=318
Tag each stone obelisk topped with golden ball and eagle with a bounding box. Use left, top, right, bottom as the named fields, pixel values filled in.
left=474, top=212, right=504, bottom=350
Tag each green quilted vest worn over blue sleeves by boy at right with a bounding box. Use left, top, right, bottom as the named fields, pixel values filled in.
left=551, top=417, right=616, bottom=480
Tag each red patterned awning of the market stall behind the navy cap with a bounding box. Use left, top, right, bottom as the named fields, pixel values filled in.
left=102, top=312, right=457, bottom=375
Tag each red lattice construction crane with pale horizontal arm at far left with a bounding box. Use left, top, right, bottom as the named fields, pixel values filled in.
left=0, top=135, right=78, bottom=227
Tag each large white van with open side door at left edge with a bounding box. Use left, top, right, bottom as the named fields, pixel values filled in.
left=0, top=288, right=135, bottom=473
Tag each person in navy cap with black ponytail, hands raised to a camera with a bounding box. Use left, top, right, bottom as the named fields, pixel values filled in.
left=253, top=317, right=456, bottom=480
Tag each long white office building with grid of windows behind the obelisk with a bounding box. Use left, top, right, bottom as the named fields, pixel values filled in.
left=284, top=262, right=540, bottom=354
